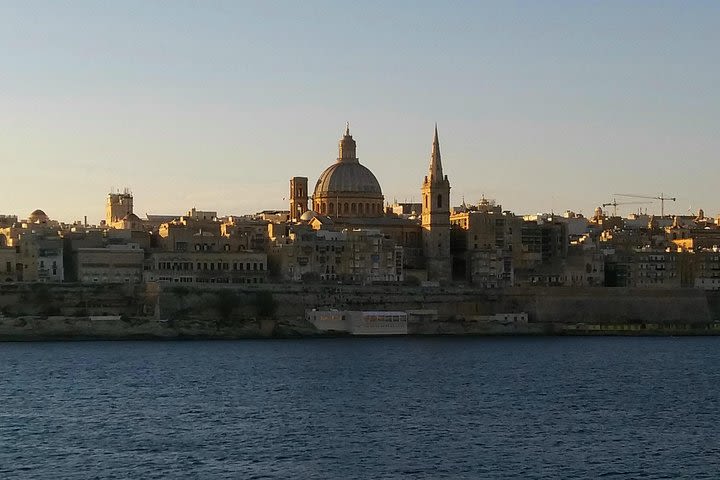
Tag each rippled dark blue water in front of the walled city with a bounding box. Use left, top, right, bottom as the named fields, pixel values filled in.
left=0, top=338, right=720, bottom=479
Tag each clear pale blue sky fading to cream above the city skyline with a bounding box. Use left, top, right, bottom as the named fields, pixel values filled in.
left=0, top=0, right=720, bottom=223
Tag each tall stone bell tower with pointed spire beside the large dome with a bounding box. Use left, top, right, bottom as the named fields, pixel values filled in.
left=422, top=125, right=452, bottom=282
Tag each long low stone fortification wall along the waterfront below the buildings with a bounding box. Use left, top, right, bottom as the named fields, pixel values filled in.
left=0, top=284, right=720, bottom=339
